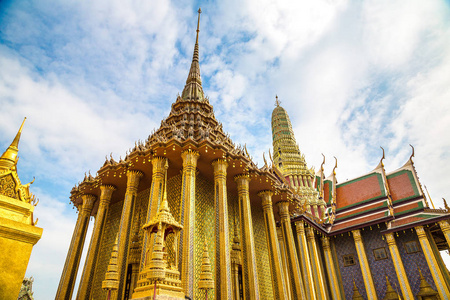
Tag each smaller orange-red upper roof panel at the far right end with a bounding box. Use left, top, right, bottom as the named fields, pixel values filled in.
left=387, top=170, right=420, bottom=203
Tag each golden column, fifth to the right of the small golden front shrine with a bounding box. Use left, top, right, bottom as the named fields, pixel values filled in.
left=277, top=201, right=306, bottom=299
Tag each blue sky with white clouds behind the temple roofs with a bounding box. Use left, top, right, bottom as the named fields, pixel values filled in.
left=0, top=0, right=450, bottom=299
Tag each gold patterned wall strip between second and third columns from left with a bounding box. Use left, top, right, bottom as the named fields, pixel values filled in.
left=91, top=201, right=123, bottom=299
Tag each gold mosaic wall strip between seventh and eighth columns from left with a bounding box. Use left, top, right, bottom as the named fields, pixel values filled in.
left=252, top=204, right=273, bottom=300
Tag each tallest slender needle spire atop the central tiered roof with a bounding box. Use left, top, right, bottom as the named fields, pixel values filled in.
left=181, top=8, right=205, bottom=101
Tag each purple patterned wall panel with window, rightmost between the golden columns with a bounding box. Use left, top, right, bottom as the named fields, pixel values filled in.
left=395, top=229, right=436, bottom=295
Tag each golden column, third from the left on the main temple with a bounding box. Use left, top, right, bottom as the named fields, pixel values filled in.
left=116, top=170, right=144, bottom=299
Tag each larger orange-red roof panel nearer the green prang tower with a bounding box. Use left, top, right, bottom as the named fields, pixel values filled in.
left=336, top=173, right=386, bottom=210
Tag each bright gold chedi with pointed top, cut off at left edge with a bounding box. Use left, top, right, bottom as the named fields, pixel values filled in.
left=0, top=120, right=42, bottom=299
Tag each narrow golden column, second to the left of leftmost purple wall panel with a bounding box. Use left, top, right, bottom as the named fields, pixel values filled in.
left=306, top=226, right=327, bottom=299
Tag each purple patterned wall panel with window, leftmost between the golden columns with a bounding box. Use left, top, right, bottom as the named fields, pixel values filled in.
left=334, top=233, right=367, bottom=300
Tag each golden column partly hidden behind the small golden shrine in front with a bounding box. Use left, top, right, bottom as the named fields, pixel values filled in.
left=139, top=156, right=167, bottom=271
